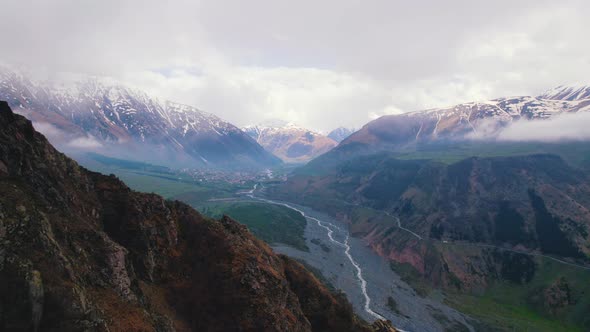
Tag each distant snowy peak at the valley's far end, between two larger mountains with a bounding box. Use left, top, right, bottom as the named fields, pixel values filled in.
left=242, top=120, right=337, bottom=163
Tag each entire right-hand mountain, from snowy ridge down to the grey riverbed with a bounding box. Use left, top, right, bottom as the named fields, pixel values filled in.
left=267, top=87, right=590, bottom=330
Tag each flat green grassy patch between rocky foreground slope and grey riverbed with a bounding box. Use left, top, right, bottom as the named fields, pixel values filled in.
left=199, top=202, right=309, bottom=251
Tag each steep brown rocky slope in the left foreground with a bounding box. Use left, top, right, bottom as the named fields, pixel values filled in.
left=0, top=102, right=393, bottom=331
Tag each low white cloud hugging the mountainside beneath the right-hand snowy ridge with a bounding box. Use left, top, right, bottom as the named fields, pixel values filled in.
left=497, top=112, right=590, bottom=142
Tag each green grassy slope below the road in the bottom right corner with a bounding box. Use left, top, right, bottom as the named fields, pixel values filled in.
left=391, top=251, right=590, bottom=331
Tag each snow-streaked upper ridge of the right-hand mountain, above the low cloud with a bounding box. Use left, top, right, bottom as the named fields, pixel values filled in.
left=341, top=87, right=590, bottom=149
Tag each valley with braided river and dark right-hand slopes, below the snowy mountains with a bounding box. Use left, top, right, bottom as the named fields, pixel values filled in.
left=4, top=85, right=590, bottom=331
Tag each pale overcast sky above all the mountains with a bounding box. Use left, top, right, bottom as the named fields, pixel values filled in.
left=0, top=0, right=590, bottom=131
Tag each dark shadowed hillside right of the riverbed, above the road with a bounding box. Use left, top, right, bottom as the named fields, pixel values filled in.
left=269, top=153, right=590, bottom=287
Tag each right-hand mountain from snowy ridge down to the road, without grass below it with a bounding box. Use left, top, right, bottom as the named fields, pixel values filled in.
left=279, top=82, right=590, bottom=268
